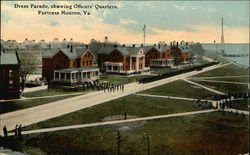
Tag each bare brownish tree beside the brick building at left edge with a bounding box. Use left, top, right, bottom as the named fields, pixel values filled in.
left=19, top=52, right=38, bottom=93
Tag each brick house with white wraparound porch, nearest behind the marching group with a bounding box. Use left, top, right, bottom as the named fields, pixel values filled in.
left=42, top=45, right=99, bottom=85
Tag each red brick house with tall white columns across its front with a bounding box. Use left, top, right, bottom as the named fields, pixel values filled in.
left=97, top=45, right=149, bottom=74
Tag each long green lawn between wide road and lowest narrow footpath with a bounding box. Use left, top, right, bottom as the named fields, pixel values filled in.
left=23, top=95, right=199, bottom=130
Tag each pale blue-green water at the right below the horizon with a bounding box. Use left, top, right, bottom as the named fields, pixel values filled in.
left=202, top=44, right=249, bottom=67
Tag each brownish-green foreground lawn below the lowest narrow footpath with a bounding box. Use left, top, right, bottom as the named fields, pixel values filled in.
left=11, top=112, right=249, bottom=155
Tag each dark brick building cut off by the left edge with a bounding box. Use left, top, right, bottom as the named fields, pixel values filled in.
left=0, top=45, right=20, bottom=99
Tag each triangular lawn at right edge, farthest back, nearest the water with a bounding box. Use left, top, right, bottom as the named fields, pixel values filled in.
left=195, top=64, right=249, bottom=77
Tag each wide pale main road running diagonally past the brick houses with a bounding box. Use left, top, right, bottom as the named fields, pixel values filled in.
left=0, top=64, right=227, bottom=134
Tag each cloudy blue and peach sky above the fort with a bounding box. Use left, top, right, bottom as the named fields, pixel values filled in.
left=1, top=1, right=249, bottom=44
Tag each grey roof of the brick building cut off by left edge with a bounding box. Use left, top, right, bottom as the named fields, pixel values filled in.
left=0, top=51, right=20, bottom=65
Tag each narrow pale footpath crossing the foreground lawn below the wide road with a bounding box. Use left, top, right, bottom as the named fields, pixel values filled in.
left=9, top=109, right=218, bottom=135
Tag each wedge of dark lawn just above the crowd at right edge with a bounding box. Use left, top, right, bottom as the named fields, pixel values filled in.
left=195, top=81, right=248, bottom=93
